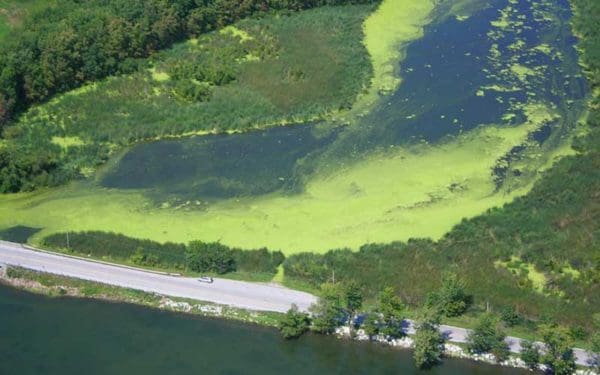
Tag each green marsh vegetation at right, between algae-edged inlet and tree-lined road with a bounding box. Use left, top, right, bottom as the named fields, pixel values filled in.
left=284, top=0, right=600, bottom=327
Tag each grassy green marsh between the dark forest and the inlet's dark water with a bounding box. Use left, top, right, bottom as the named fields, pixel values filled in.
left=15, top=6, right=372, bottom=148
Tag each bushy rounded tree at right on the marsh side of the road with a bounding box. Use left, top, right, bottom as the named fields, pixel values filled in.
left=426, top=273, right=473, bottom=317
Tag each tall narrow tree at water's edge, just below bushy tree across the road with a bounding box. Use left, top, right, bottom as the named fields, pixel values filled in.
left=413, top=308, right=444, bottom=368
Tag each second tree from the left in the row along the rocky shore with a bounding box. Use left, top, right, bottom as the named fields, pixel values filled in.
left=309, top=283, right=346, bottom=333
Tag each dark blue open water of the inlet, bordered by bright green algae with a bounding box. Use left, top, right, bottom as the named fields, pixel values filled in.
left=102, top=0, right=588, bottom=200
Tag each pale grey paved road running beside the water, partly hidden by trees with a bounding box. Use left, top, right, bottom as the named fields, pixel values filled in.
left=0, top=241, right=590, bottom=365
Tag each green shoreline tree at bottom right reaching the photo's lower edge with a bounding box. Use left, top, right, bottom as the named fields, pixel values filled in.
left=540, top=324, right=576, bottom=375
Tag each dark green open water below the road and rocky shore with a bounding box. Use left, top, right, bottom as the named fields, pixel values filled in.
left=0, top=286, right=525, bottom=375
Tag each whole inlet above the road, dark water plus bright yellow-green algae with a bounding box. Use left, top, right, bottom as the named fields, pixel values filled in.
left=0, top=0, right=587, bottom=253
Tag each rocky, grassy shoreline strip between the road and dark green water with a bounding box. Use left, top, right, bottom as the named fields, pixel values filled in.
left=0, top=266, right=597, bottom=375
